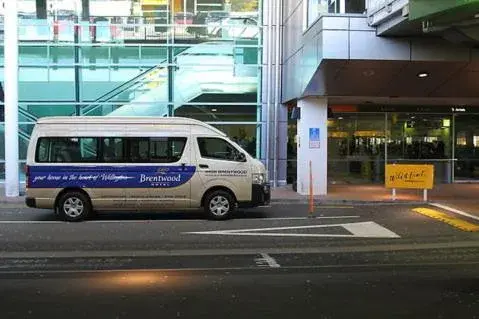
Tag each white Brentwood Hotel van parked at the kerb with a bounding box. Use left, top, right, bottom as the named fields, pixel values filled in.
left=26, top=117, right=270, bottom=221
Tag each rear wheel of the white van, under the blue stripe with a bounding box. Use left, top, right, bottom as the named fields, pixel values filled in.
left=57, top=192, right=93, bottom=222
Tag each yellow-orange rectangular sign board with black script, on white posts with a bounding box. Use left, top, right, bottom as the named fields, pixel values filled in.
left=386, top=164, right=434, bottom=189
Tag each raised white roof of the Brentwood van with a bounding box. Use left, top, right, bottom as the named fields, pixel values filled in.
left=37, top=116, right=226, bottom=136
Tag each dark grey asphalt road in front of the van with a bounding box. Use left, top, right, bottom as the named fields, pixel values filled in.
left=0, top=205, right=479, bottom=318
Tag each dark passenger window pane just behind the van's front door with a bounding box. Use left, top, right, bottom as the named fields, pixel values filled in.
left=150, top=137, right=186, bottom=163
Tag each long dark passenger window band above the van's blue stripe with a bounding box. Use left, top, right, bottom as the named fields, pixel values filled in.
left=35, top=137, right=187, bottom=163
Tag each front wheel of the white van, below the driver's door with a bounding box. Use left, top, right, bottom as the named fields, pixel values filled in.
left=204, top=190, right=236, bottom=220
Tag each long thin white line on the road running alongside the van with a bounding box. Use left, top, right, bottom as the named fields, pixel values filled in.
left=0, top=215, right=360, bottom=225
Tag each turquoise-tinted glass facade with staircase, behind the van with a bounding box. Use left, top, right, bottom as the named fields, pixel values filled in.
left=0, top=0, right=262, bottom=178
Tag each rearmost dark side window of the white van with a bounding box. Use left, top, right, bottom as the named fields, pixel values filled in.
left=35, top=137, right=98, bottom=163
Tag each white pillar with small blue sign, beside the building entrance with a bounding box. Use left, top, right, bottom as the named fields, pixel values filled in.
left=297, top=97, right=328, bottom=195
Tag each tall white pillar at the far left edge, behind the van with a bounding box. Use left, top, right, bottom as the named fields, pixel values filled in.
left=4, top=1, right=20, bottom=197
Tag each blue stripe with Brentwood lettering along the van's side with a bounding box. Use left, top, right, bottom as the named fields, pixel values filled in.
left=28, top=165, right=196, bottom=188
